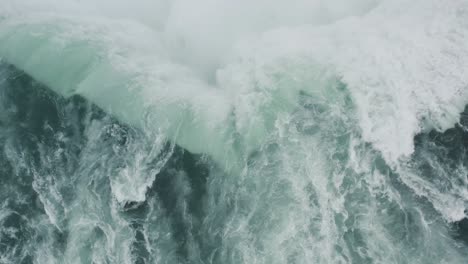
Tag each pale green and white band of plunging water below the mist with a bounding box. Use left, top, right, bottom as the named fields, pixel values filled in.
left=0, top=0, right=468, bottom=185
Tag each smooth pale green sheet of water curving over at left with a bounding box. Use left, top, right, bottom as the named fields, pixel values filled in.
left=0, top=15, right=344, bottom=177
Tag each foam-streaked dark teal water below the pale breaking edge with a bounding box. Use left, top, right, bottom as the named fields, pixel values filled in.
left=0, top=65, right=468, bottom=263
